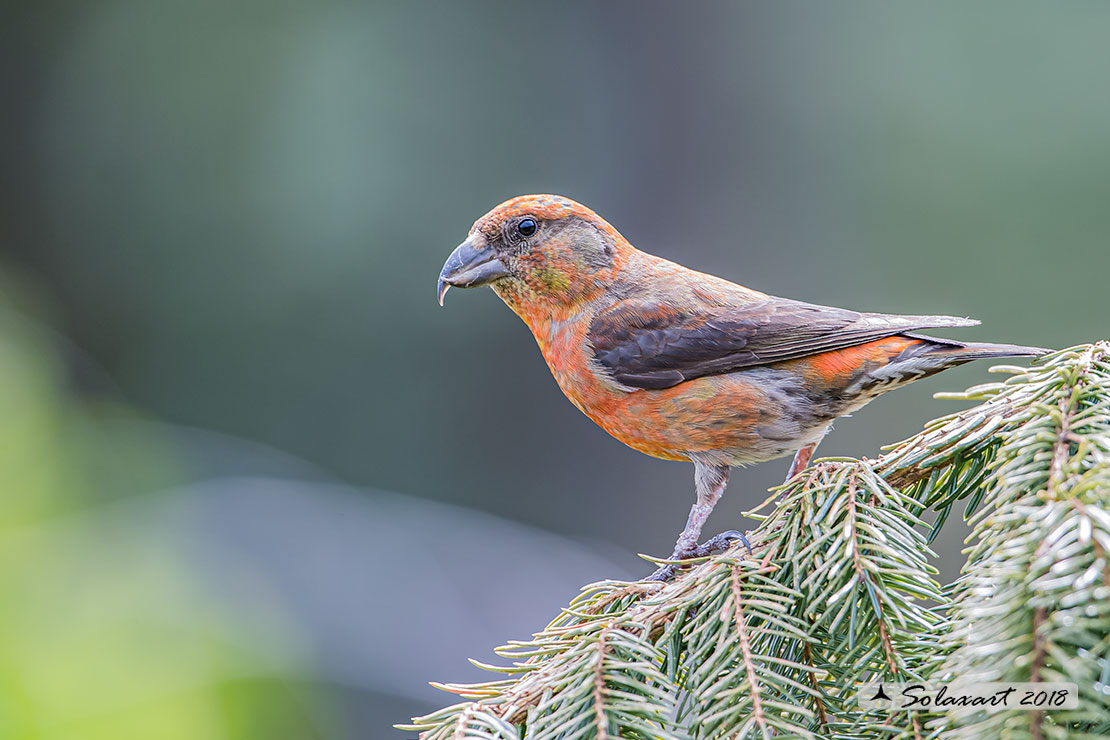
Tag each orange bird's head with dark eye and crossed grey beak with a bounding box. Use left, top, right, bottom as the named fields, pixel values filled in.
left=437, top=195, right=632, bottom=313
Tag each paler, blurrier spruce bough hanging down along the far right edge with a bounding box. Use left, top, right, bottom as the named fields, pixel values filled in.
left=927, top=344, right=1110, bottom=739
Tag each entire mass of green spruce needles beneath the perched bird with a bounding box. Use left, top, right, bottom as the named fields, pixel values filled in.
left=403, top=342, right=1110, bottom=740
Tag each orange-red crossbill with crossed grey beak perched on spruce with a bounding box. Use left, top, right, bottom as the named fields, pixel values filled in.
left=436, top=194, right=1047, bottom=580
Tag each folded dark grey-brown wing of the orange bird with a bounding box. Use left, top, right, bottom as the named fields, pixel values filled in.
left=589, top=298, right=978, bottom=388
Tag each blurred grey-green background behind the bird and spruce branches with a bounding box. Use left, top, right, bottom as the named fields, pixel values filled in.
left=0, top=0, right=1110, bottom=740
